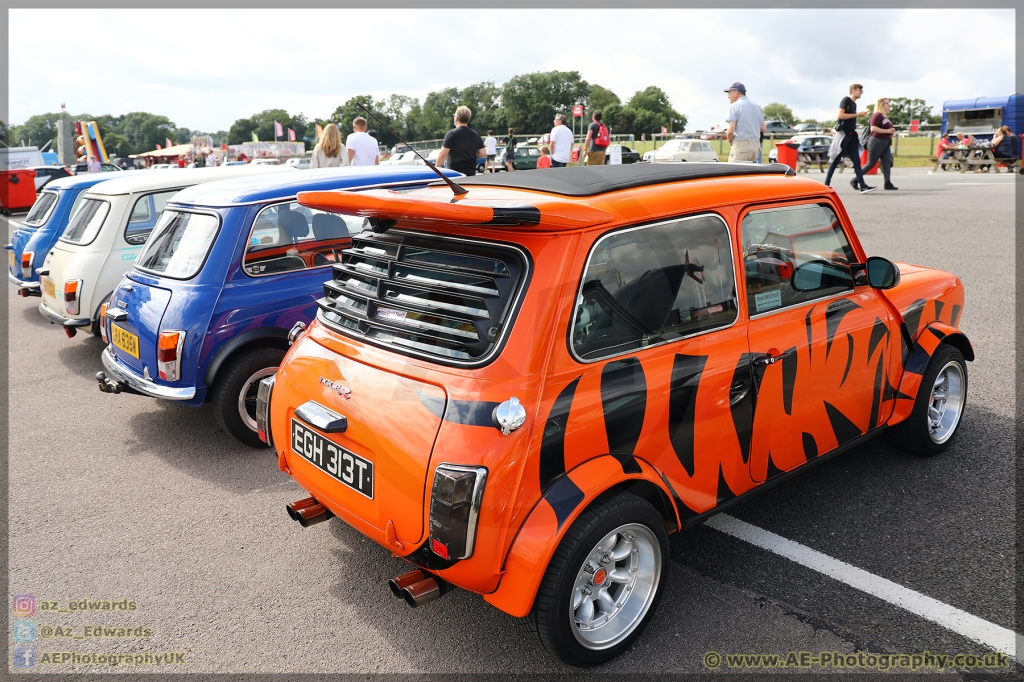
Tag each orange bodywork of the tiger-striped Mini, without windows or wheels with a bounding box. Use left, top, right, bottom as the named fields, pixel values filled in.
left=270, top=168, right=964, bottom=615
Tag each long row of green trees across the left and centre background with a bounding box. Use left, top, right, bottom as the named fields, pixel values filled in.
left=6, top=71, right=687, bottom=156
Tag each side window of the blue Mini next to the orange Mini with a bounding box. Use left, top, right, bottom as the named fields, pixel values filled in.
left=242, top=202, right=362, bottom=276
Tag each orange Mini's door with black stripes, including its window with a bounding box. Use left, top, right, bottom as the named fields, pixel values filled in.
left=739, top=203, right=900, bottom=482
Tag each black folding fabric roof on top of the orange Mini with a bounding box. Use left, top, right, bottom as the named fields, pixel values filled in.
left=440, top=162, right=796, bottom=197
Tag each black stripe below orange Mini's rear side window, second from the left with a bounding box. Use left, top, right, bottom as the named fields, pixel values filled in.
left=601, top=357, right=647, bottom=454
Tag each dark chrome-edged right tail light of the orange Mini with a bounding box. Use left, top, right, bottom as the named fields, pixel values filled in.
left=430, top=464, right=487, bottom=560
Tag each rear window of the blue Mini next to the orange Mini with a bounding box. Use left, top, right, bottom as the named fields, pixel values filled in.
left=136, top=211, right=220, bottom=280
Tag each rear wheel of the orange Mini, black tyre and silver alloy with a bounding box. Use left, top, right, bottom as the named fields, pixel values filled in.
left=521, top=494, right=669, bottom=668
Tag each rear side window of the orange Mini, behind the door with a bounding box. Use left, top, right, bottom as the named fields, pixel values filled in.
left=570, top=215, right=737, bottom=360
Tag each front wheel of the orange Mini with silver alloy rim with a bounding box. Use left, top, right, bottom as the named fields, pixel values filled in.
left=886, top=343, right=967, bottom=457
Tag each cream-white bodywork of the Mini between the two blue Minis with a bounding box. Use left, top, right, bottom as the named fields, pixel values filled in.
left=40, top=166, right=294, bottom=332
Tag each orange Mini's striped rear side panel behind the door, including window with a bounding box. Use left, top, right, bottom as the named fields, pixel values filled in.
left=557, top=213, right=753, bottom=516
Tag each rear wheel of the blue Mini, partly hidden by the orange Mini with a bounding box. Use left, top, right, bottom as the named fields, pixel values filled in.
left=213, top=347, right=285, bottom=447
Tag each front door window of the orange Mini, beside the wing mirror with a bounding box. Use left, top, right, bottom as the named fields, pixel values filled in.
left=742, top=204, right=854, bottom=316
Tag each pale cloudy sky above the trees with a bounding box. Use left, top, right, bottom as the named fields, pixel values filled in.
left=9, top=9, right=1015, bottom=132
